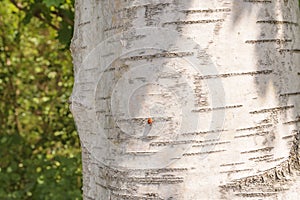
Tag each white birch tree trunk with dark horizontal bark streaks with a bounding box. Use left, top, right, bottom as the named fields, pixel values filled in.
left=71, top=0, right=300, bottom=200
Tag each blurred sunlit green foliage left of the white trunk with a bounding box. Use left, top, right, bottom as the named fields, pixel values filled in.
left=0, top=0, right=82, bottom=200
